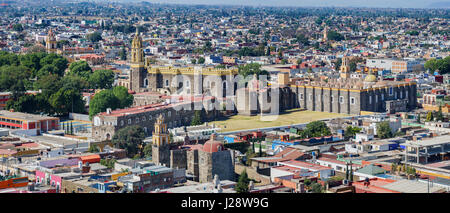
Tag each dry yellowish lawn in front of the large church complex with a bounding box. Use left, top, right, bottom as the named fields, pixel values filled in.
left=209, top=109, right=350, bottom=132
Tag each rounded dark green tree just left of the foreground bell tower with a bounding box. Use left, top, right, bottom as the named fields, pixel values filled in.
left=112, top=125, right=145, bottom=158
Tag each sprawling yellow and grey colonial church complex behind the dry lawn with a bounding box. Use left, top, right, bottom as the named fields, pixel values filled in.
left=92, top=28, right=417, bottom=140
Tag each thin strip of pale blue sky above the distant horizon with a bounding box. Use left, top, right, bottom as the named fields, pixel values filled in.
left=134, top=0, right=450, bottom=8
